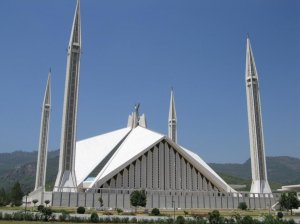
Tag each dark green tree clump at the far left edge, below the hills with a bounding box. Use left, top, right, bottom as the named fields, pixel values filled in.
left=0, top=182, right=24, bottom=206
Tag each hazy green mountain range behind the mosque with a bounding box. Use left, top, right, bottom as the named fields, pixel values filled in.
left=0, top=150, right=300, bottom=193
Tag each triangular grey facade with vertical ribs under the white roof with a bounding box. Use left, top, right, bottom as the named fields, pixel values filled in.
left=96, top=141, right=223, bottom=192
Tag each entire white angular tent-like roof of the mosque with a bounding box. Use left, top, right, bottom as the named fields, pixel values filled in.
left=75, top=126, right=235, bottom=192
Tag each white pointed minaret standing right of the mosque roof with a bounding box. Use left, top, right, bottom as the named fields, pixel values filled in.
left=246, top=36, right=271, bottom=193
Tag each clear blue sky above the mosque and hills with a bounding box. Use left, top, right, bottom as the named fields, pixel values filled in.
left=0, top=0, right=300, bottom=163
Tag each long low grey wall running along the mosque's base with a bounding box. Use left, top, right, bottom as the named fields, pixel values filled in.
left=51, top=189, right=280, bottom=209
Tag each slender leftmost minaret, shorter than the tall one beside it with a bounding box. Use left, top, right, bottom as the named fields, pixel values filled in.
left=34, top=70, right=51, bottom=195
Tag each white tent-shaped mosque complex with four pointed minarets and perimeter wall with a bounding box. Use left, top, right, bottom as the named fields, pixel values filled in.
left=25, top=0, right=275, bottom=208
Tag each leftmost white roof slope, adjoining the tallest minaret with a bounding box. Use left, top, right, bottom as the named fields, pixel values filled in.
left=75, top=128, right=131, bottom=184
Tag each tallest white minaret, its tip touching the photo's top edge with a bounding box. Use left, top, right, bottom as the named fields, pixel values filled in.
left=54, top=0, right=81, bottom=192
